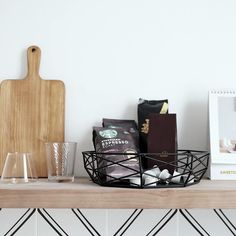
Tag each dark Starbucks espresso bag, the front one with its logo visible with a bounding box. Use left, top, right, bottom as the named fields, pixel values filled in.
left=93, top=127, right=140, bottom=181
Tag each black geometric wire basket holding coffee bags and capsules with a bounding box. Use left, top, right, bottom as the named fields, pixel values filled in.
left=82, top=150, right=210, bottom=188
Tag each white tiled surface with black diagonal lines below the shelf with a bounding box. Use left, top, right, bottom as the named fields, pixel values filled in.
left=0, top=208, right=236, bottom=236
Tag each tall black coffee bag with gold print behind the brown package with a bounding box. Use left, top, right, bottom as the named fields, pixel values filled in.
left=138, top=98, right=168, bottom=153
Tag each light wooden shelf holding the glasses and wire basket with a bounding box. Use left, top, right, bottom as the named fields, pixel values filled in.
left=0, top=178, right=236, bottom=209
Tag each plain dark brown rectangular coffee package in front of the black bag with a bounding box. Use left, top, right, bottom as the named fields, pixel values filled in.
left=147, top=114, right=177, bottom=174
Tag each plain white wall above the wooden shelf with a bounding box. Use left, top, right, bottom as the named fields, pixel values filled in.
left=0, top=0, right=236, bottom=175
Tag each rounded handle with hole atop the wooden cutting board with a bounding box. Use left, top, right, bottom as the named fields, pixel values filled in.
left=27, top=46, right=41, bottom=79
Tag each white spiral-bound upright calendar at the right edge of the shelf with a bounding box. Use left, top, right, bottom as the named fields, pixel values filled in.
left=209, top=90, right=236, bottom=180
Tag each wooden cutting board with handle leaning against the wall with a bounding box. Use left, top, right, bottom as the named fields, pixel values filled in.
left=0, top=46, right=65, bottom=177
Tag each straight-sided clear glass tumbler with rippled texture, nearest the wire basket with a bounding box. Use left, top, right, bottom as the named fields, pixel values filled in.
left=45, top=142, right=77, bottom=182
